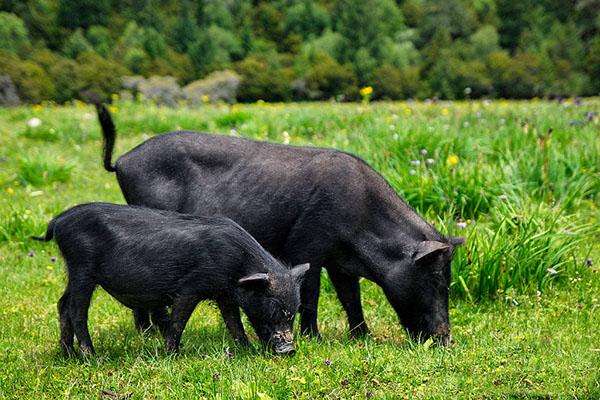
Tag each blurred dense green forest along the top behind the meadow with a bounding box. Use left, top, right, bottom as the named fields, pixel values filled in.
left=0, top=0, right=600, bottom=102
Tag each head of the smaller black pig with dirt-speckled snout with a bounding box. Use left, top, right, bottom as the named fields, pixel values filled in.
left=238, top=264, right=309, bottom=354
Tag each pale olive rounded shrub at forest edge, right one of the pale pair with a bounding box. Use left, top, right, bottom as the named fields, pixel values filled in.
left=183, top=70, right=241, bottom=104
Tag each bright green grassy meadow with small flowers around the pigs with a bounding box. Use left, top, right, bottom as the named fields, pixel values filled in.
left=0, top=99, right=600, bottom=400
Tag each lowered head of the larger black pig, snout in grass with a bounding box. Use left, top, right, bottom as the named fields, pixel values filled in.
left=382, top=238, right=464, bottom=345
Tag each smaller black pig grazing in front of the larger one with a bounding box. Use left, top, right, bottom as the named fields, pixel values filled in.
left=35, top=203, right=308, bottom=354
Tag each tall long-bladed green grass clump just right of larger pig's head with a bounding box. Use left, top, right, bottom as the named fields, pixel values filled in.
left=452, top=203, right=598, bottom=301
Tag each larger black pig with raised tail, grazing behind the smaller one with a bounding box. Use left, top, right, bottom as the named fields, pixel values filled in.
left=97, top=105, right=462, bottom=343
